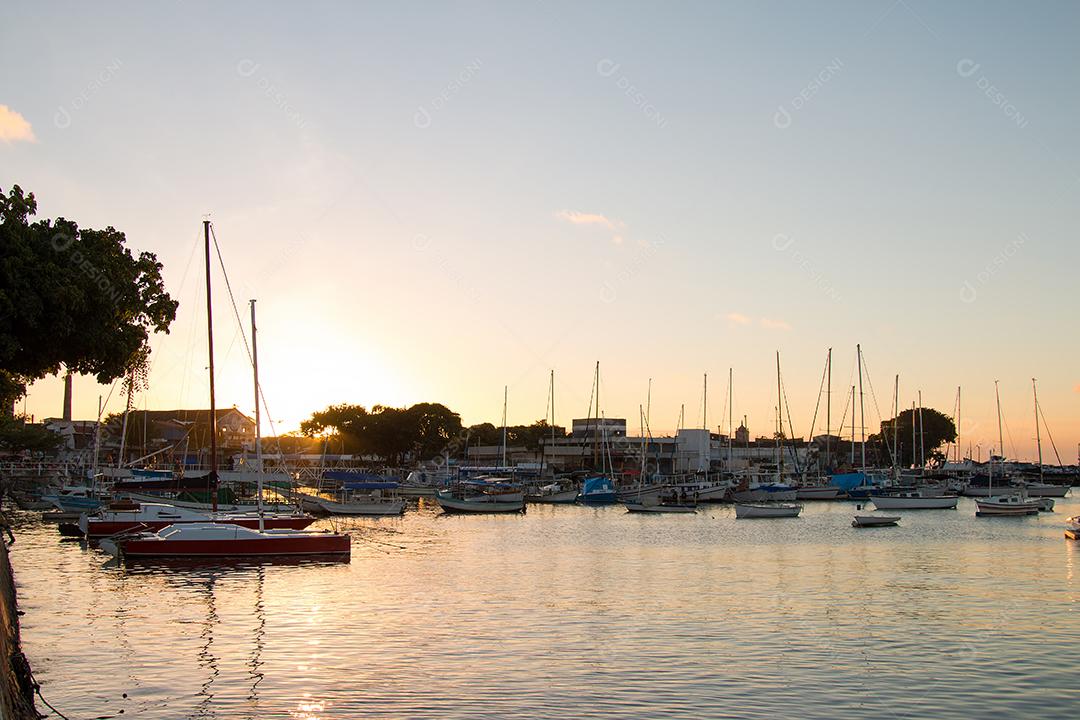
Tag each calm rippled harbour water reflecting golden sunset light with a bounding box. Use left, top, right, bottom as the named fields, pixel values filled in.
left=12, top=498, right=1080, bottom=720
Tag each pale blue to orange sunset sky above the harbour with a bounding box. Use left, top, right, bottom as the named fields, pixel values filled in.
left=0, top=0, right=1080, bottom=463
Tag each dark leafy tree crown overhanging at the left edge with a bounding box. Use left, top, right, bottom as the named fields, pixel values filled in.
left=0, top=185, right=177, bottom=417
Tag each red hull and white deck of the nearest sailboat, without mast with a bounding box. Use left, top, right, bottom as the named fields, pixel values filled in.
left=100, top=522, right=352, bottom=558
